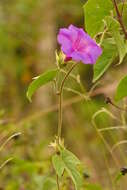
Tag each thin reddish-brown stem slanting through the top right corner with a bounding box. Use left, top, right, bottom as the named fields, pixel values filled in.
left=112, top=0, right=127, bottom=40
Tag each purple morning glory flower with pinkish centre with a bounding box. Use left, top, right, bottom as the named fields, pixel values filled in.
left=57, top=25, right=102, bottom=64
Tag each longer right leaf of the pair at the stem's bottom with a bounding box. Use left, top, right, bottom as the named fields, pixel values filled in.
left=61, top=149, right=82, bottom=190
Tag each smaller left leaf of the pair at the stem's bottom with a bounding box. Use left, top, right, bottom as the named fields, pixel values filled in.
left=52, top=154, right=65, bottom=177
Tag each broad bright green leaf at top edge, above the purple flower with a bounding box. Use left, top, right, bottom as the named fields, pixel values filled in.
left=84, top=0, right=113, bottom=37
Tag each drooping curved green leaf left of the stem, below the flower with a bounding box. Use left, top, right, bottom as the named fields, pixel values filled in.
left=27, top=70, right=57, bottom=101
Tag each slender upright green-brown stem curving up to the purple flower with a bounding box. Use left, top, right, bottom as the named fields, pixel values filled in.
left=58, top=63, right=78, bottom=143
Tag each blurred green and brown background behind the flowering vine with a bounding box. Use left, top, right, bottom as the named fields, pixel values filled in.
left=0, top=0, right=126, bottom=190
